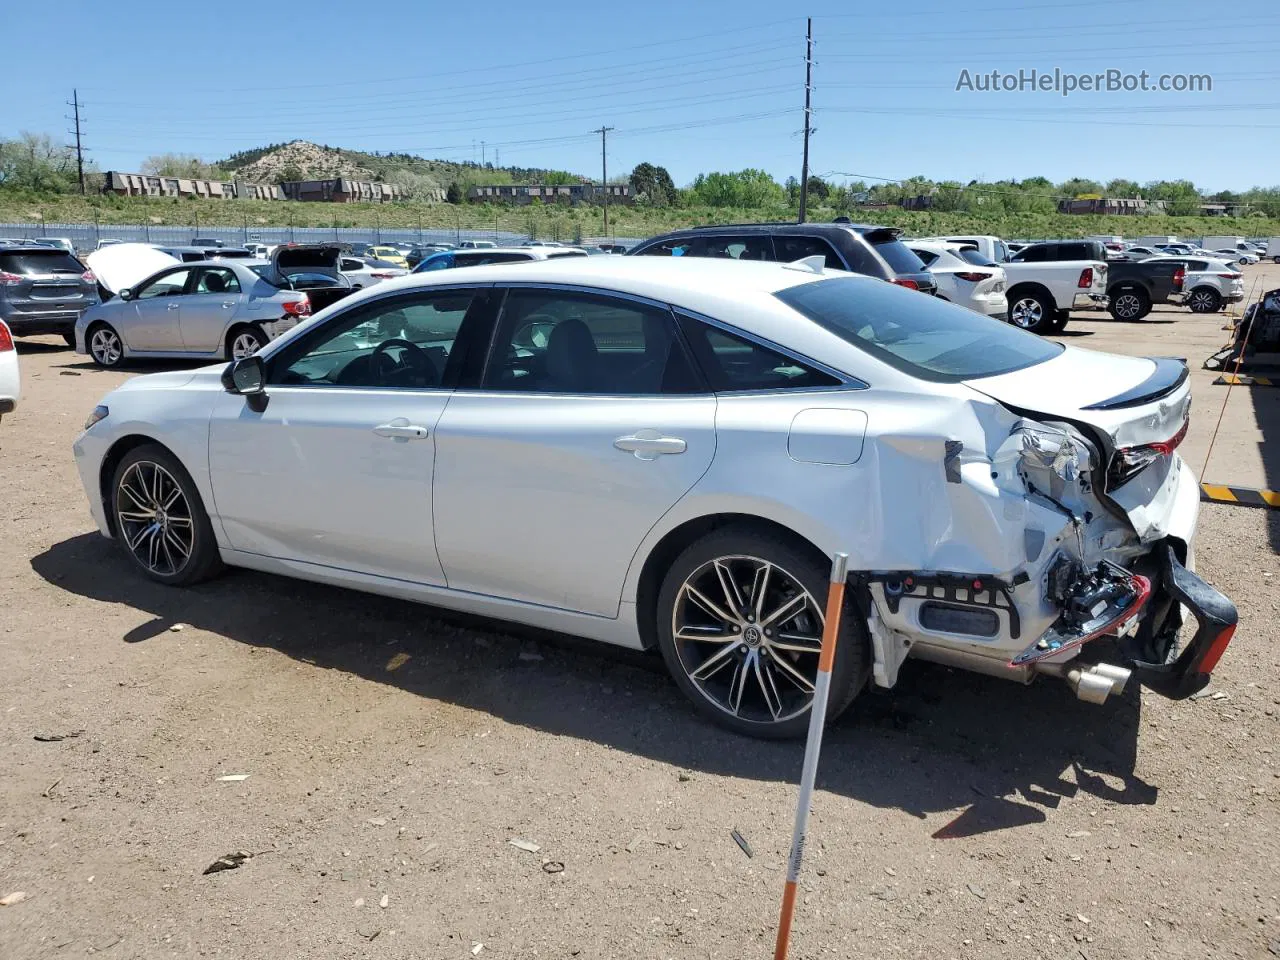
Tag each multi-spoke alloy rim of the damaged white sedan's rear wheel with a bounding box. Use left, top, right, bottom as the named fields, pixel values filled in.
left=671, top=556, right=824, bottom=723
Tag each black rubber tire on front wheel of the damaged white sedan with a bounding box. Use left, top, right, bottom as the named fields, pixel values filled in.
left=108, top=443, right=223, bottom=586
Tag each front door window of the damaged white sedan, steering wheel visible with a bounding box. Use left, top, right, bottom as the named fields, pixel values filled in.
left=270, top=291, right=479, bottom=389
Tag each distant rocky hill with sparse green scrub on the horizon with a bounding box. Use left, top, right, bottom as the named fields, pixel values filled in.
left=215, top=140, right=584, bottom=189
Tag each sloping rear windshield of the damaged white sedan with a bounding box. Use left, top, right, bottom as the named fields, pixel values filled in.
left=774, top=276, right=1062, bottom=383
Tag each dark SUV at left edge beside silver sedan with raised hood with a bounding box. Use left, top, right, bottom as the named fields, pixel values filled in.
left=0, top=246, right=97, bottom=346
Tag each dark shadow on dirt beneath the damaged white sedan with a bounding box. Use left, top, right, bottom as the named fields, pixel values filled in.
left=32, top=534, right=1157, bottom=838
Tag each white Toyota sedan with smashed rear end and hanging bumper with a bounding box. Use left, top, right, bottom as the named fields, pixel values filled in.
left=74, top=257, right=1236, bottom=736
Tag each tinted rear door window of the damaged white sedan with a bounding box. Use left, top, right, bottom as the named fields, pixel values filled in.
left=484, top=288, right=698, bottom=394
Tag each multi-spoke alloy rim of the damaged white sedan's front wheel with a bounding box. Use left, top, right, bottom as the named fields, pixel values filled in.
left=115, top=460, right=196, bottom=576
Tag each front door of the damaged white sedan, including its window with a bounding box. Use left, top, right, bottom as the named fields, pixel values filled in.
left=209, top=289, right=485, bottom=584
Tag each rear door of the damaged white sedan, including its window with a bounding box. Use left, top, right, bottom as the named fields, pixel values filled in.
left=434, top=285, right=716, bottom=617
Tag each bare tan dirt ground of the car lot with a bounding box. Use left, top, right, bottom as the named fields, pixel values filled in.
left=0, top=266, right=1280, bottom=960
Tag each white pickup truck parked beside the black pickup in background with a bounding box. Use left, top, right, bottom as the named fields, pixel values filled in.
left=929, top=236, right=1107, bottom=333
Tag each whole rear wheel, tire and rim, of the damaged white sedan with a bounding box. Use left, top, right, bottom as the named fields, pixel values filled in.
left=657, top=526, right=869, bottom=739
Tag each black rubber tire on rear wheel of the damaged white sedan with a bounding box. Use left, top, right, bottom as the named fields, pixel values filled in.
left=655, top=525, right=870, bottom=740
